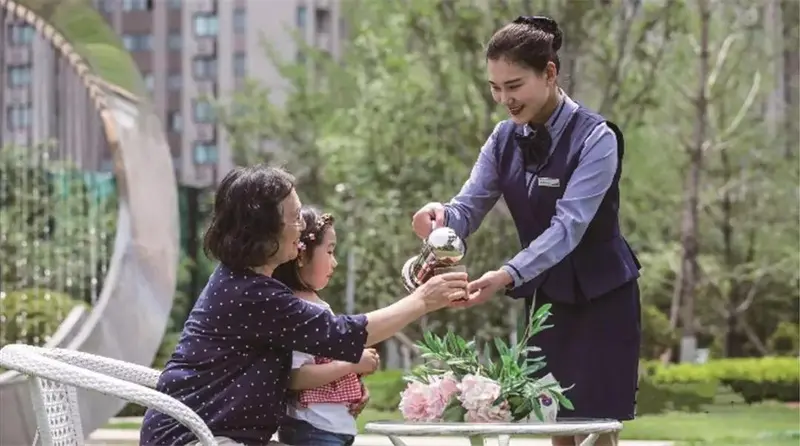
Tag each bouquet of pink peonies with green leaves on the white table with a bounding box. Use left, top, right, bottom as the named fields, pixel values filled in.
left=400, top=304, right=572, bottom=423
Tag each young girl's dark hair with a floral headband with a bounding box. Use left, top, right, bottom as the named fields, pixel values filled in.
left=272, top=206, right=334, bottom=291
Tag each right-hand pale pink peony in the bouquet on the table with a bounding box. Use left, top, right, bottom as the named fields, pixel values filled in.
left=458, top=375, right=511, bottom=423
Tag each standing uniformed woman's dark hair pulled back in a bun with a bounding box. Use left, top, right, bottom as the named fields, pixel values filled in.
left=486, top=16, right=563, bottom=73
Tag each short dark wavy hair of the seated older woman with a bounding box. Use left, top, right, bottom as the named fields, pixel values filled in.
left=203, top=165, right=295, bottom=270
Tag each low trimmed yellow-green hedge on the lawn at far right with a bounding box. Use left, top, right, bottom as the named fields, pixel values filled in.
left=652, top=357, right=800, bottom=403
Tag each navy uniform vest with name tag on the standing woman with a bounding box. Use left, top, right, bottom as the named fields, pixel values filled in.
left=494, top=107, right=640, bottom=303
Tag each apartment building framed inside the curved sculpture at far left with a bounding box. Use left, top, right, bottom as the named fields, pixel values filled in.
left=0, top=8, right=111, bottom=172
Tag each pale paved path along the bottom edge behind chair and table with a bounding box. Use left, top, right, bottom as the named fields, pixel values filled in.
left=88, top=429, right=673, bottom=446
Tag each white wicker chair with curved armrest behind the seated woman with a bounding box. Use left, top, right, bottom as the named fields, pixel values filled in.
left=0, top=344, right=217, bottom=446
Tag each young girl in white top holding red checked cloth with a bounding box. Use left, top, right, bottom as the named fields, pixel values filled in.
left=273, top=207, right=379, bottom=446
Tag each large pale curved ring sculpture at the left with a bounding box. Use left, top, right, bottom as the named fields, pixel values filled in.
left=0, top=0, right=179, bottom=445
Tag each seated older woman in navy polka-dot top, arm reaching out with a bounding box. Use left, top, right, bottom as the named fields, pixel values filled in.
left=140, top=166, right=467, bottom=445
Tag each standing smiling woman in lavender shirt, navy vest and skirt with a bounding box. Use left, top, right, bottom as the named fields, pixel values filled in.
left=413, top=17, right=641, bottom=446
